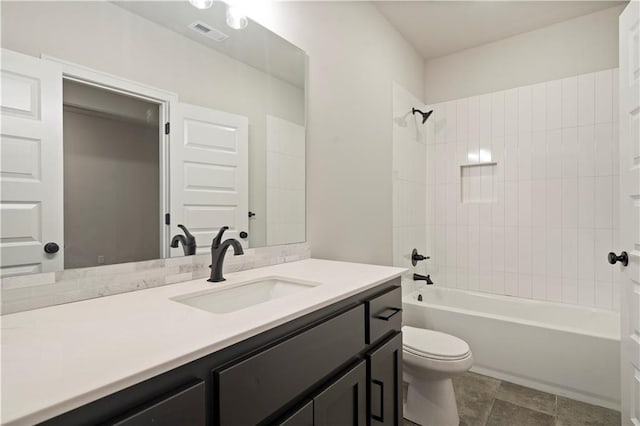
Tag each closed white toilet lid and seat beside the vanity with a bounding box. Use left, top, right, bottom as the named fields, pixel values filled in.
left=402, top=326, right=471, bottom=360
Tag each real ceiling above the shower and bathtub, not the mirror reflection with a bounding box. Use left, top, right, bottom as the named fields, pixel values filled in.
left=374, top=0, right=626, bottom=59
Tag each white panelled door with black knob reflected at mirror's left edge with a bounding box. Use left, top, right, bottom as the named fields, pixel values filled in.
left=0, top=49, right=64, bottom=276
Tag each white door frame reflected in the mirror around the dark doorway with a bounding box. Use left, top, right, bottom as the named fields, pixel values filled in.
left=41, top=54, right=178, bottom=259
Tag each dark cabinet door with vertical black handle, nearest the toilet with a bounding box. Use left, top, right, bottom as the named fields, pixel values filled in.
left=367, top=333, right=402, bottom=426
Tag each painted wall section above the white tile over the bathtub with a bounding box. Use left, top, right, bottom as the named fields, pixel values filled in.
left=424, top=6, right=624, bottom=103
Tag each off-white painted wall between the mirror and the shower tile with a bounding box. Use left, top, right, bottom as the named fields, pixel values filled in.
left=240, top=2, right=424, bottom=265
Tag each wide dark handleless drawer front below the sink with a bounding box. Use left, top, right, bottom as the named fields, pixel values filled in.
left=214, top=305, right=365, bottom=426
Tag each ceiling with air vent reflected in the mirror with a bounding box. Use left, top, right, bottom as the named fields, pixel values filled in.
left=113, top=0, right=306, bottom=88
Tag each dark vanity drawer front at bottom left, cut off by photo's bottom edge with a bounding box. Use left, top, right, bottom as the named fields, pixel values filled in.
left=109, top=381, right=205, bottom=426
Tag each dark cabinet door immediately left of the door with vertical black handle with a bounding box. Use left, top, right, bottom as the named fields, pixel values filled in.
left=313, top=361, right=367, bottom=426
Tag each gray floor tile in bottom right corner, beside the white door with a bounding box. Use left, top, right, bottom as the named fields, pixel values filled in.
left=556, top=396, right=620, bottom=426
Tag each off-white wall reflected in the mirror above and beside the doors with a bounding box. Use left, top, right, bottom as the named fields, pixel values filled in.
left=2, top=1, right=305, bottom=247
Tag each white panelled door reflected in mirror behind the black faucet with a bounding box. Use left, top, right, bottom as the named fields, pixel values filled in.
left=170, top=103, right=249, bottom=256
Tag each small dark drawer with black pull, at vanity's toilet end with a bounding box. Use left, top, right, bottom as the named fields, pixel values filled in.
left=366, top=287, right=402, bottom=344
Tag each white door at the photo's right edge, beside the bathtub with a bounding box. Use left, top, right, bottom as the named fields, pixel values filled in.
left=617, top=1, right=640, bottom=426
